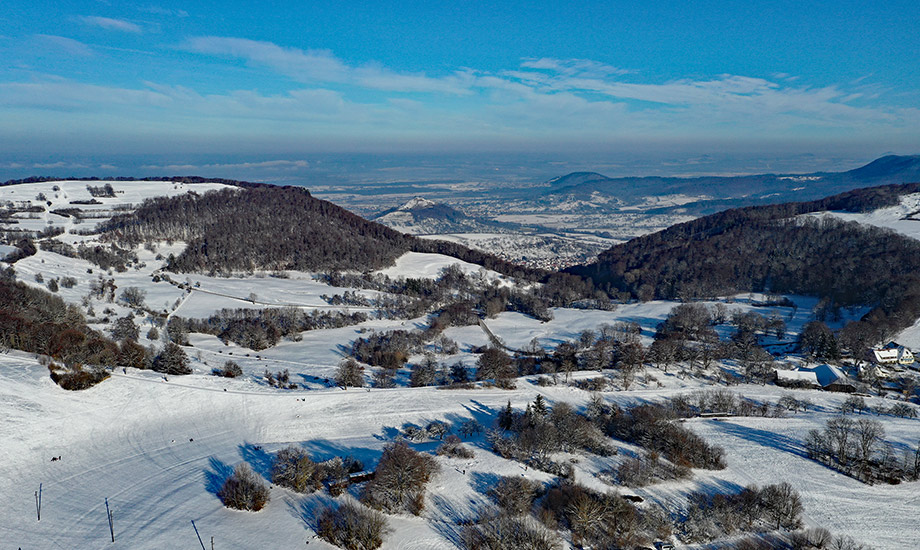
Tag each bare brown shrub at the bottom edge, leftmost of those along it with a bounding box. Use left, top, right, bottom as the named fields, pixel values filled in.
left=316, top=502, right=390, bottom=550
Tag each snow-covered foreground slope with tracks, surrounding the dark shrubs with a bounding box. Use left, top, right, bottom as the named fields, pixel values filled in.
left=0, top=352, right=920, bottom=549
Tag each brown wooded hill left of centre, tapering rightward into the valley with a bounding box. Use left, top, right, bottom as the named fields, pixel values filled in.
left=100, top=184, right=546, bottom=279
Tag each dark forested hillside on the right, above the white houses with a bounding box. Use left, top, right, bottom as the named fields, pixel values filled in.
left=569, top=183, right=920, bottom=336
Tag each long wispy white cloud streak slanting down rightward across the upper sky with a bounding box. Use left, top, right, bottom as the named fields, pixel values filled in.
left=181, top=36, right=896, bottom=130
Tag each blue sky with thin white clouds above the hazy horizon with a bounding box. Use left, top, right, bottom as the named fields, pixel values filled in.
left=0, top=0, right=920, bottom=179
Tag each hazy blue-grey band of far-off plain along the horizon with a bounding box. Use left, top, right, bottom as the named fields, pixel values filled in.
left=0, top=151, right=910, bottom=187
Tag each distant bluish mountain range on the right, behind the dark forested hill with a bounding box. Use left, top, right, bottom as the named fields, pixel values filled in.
left=543, top=155, right=920, bottom=214
